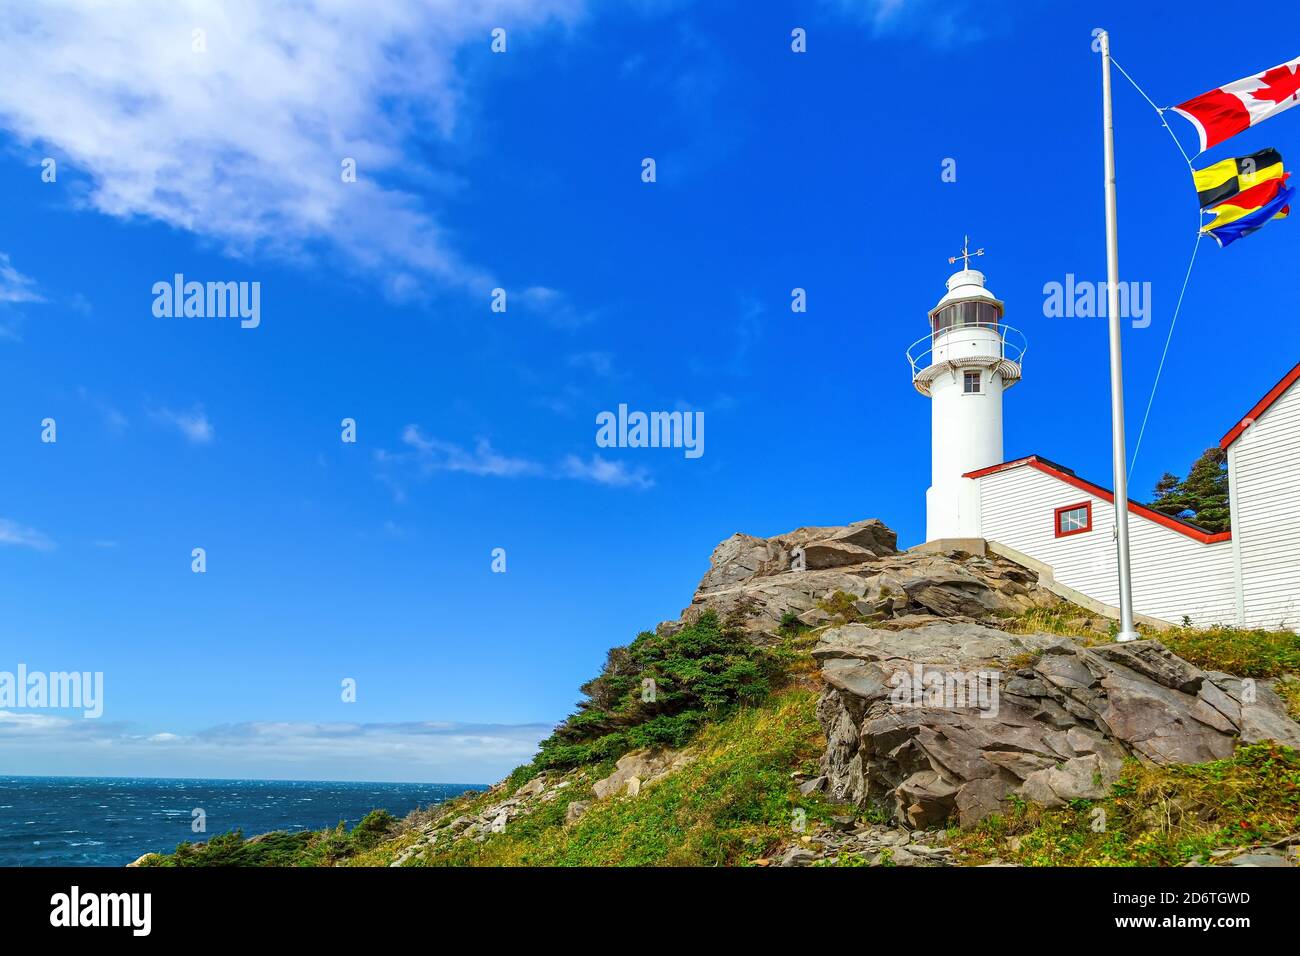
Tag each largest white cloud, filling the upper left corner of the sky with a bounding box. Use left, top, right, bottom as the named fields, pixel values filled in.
left=0, top=0, right=582, bottom=295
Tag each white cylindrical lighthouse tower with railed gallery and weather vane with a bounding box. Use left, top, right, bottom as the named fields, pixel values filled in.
left=907, top=237, right=1026, bottom=541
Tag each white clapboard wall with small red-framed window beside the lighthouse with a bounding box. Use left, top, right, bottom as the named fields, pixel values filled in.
left=971, top=464, right=1236, bottom=626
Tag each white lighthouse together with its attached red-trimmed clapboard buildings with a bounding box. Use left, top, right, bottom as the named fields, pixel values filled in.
left=907, top=261, right=1300, bottom=630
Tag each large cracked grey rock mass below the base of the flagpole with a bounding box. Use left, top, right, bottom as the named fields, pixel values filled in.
left=813, top=622, right=1300, bottom=827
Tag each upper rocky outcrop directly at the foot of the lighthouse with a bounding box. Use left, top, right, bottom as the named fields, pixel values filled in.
left=681, top=519, right=1061, bottom=639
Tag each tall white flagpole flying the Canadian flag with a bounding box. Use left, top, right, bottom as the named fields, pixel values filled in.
left=1100, top=31, right=1139, bottom=641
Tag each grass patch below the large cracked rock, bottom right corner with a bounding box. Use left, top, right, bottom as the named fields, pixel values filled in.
left=950, top=744, right=1300, bottom=866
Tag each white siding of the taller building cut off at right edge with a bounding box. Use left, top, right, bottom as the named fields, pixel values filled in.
left=1232, top=382, right=1300, bottom=630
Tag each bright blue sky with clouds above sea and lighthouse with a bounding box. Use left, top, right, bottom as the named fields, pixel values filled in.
left=0, top=0, right=1300, bottom=782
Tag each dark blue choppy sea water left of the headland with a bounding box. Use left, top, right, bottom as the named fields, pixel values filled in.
left=0, top=777, right=482, bottom=866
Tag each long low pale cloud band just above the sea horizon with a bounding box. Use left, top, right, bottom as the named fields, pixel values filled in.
left=0, top=710, right=551, bottom=783
